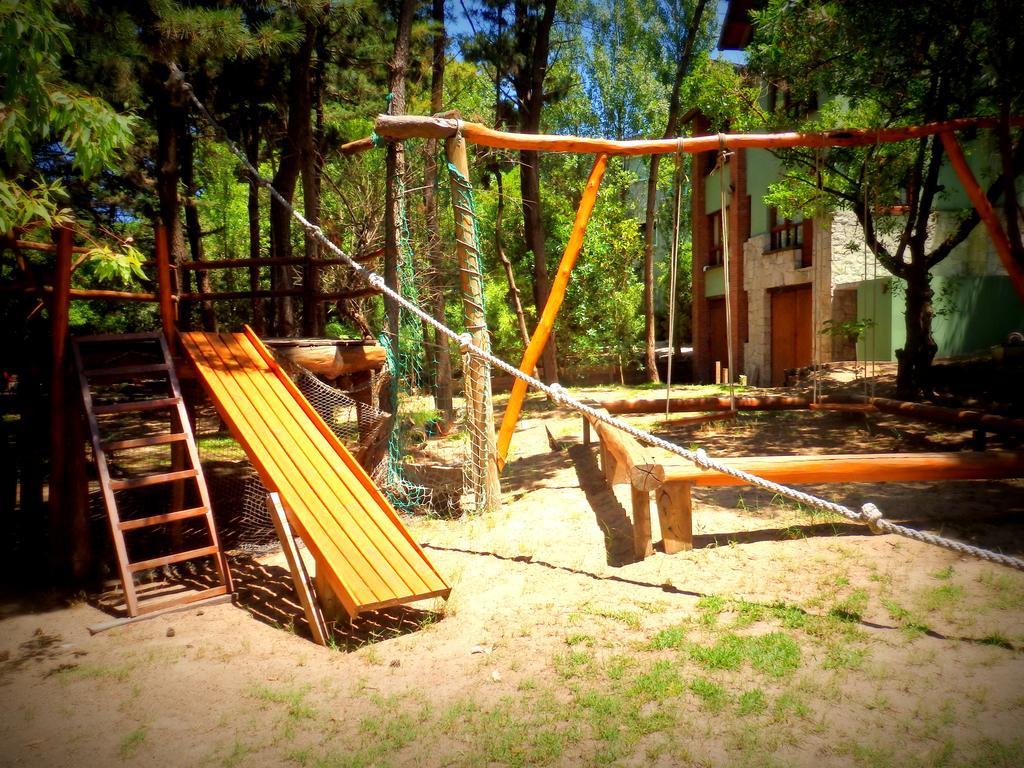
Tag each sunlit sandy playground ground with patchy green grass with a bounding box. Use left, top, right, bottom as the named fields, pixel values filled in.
left=0, top=382, right=1024, bottom=766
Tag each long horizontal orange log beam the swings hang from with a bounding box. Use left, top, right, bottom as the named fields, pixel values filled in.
left=374, top=115, right=1024, bottom=156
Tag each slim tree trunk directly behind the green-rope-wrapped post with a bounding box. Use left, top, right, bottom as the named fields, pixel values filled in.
left=423, top=0, right=455, bottom=424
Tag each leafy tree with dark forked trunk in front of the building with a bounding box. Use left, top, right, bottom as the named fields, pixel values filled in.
left=751, top=0, right=1024, bottom=397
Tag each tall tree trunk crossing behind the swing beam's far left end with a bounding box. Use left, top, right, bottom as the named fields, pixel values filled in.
left=384, top=0, right=416, bottom=368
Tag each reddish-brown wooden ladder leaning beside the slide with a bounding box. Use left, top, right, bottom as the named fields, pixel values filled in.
left=73, top=332, right=231, bottom=617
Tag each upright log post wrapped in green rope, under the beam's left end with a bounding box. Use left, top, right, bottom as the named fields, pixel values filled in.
left=444, top=135, right=502, bottom=509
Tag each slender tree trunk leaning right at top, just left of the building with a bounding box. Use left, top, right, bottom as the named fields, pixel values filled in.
left=643, top=0, right=707, bottom=382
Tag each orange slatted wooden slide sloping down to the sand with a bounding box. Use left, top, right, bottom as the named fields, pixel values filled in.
left=181, top=327, right=452, bottom=617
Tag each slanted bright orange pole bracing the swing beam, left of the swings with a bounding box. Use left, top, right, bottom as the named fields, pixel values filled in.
left=498, top=153, right=608, bottom=468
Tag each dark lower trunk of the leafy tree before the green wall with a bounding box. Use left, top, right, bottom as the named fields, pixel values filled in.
left=896, top=264, right=939, bottom=400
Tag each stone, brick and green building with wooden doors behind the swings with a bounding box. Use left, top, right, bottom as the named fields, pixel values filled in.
left=690, top=0, right=1024, bottom=386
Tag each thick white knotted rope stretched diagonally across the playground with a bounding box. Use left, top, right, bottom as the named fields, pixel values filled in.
left=181, top=76, right=1024, bottom=570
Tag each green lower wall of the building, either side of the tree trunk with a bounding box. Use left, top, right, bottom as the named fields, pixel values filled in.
left=857, top=275, right=1024, bottom=360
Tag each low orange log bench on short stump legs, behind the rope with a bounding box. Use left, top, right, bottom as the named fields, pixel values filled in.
left=589, top=411, right=1024, bottom=559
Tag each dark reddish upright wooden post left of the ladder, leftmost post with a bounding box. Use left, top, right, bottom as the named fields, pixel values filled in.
left=49, top=226, right=74, bottom=574
